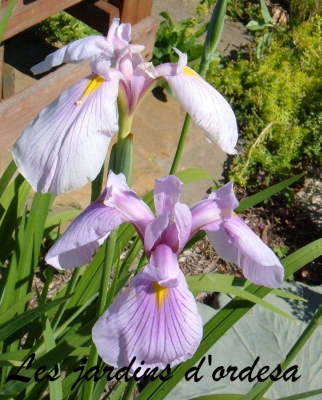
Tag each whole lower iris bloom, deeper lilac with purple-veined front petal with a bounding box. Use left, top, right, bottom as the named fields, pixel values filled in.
left=46, top=172, right=284, bottom=373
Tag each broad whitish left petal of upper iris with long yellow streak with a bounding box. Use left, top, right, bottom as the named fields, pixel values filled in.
left=13, top=75, right=118, bottom=194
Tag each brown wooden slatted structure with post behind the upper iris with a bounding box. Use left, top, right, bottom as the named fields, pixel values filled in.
left=0, top=0, right=157, bottom=151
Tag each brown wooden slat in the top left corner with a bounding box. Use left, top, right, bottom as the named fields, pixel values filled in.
left=0, top=0, right=81, bottom=41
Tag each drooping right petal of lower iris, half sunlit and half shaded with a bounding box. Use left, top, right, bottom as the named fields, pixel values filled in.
left=206, top=216, right=284, bottom=288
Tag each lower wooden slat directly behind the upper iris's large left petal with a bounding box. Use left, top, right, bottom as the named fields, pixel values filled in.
left=0, top=61, right=90, bottom=151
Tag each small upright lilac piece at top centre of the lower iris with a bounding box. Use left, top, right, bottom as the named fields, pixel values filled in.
left=154, top=175, right=183, bottom=219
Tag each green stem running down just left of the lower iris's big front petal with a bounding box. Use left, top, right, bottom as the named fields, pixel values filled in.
left=83, top=229, right=117, bottom=399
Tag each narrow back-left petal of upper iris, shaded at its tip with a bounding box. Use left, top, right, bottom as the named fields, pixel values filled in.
left=31, top=35, right=113, bottom=75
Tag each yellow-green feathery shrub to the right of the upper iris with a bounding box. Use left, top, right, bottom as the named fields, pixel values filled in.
left=207, top=16, right=322, bottom=186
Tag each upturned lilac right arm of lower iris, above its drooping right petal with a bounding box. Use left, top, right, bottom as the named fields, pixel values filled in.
left=190, top=182, right=239, bottom=235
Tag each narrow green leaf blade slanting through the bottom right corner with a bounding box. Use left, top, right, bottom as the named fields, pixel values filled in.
left=241, top=304, right=322, bottom=400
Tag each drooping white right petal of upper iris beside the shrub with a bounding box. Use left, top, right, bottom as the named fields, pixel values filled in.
left=164, top=67, right=238, bottom=154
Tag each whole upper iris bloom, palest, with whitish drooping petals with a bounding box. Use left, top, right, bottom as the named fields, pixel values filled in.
left=13, top=19, right=237, bottom=194
